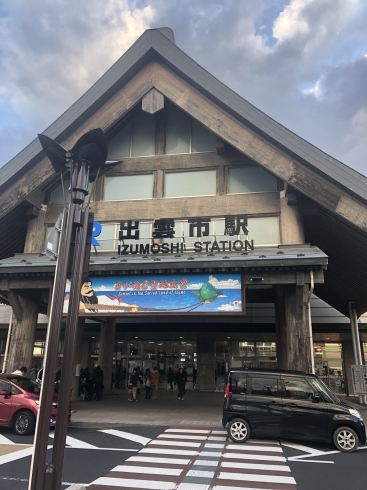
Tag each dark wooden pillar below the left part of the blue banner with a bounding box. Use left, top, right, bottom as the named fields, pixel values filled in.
left=98, top=317, right=116, bottom=393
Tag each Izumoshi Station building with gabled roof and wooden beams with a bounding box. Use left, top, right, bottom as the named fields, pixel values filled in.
left=0, top=28, right=367, bottom=393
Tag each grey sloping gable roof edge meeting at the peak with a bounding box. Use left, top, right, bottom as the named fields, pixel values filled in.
left=0, top=28, right=367, bottom=200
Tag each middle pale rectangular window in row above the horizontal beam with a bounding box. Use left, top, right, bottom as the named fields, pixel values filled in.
left=165, top=170, right=217, bottom=197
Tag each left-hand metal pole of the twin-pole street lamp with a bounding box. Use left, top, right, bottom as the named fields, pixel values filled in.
left=28, top=204, right=76, bottom=490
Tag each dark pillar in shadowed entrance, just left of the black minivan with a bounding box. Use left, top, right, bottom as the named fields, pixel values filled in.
left=196, top=335, right=215, bottom=390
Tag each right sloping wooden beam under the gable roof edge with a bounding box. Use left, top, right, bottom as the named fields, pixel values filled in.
left=154, top=63, right=367, bottom=233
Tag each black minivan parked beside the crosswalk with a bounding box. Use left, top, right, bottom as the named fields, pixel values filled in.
left=222, top=369, right=366, bottom=452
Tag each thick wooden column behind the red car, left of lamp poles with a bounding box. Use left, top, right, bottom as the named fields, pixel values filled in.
left=6, top=290, right=39, bottom=374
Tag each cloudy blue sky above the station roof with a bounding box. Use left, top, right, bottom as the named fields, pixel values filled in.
left=0, top=0, right=367, bottom=175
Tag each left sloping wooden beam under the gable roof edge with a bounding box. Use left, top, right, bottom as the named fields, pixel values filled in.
left=0, top=63, right=154, bottom=219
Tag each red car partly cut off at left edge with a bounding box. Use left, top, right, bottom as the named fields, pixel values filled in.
left=0, top=374, right=61, bottom=436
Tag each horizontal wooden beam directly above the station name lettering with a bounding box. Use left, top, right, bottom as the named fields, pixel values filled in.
left=45, top=192, right=280, bottom=224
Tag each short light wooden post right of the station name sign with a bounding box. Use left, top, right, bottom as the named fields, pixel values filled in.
left=280, top=191, right=305, bottom=245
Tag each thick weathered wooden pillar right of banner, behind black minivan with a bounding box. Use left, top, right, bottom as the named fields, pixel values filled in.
left=274, top=284, right=312, bottom=372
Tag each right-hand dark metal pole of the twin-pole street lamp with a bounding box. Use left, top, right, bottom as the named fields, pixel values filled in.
left=45, top=208, right=89, bottom=490
